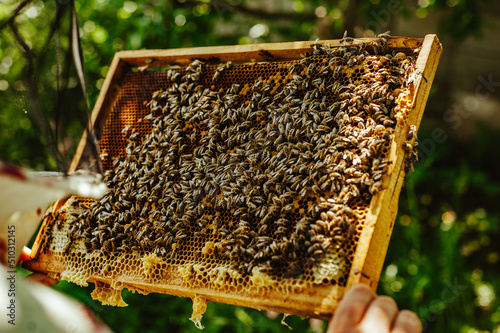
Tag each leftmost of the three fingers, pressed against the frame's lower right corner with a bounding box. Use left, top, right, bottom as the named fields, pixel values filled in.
left=327, top=284, right=376, bottom=333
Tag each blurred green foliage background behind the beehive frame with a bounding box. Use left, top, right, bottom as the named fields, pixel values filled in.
left=0, top=0, right=500, bottom=333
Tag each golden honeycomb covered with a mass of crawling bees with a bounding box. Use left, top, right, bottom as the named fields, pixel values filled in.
left=31, top=38, right=424, bottom=327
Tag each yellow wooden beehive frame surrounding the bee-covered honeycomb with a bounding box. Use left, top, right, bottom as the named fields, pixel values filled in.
left=26, top=35, right=441, bottom=319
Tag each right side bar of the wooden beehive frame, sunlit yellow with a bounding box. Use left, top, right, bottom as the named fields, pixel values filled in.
left=347, top=35, right=442, bottom=291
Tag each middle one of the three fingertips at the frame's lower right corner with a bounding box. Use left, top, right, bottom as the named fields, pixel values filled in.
left=359, top=296, right=398, bottom=333
